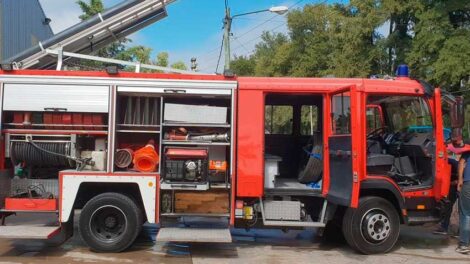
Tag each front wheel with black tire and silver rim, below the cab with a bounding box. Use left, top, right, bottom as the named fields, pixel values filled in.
left=343, top=197, right=400, bottom=255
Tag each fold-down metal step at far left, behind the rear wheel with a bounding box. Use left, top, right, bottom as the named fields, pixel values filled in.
left=0, top=225, right=61, bottom=239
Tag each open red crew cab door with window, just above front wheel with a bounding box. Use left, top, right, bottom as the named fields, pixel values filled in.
left=323, top=85, right=365, bottom=207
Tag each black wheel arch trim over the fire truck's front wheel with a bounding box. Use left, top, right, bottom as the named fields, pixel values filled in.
left=359, top=179, right=407, bottom=224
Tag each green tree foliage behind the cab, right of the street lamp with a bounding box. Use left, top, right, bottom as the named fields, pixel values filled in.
left=231, top=0, right=470, bottom=91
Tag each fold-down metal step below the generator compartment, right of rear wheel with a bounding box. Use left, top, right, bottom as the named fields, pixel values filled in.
left=157, top=227, right=232, bottom=243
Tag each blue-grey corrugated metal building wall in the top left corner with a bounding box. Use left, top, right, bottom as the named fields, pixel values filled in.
left=0, top=0, right=54, bottom=61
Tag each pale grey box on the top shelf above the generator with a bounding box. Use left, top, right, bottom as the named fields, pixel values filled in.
left=163, top=103, right=227, bottom=124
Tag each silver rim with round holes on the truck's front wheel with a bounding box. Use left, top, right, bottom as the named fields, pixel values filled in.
left=361, top=208, right=392, bottom=244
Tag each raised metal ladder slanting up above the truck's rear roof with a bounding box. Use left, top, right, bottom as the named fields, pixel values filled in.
left=5, top=0, right=175, bottom=69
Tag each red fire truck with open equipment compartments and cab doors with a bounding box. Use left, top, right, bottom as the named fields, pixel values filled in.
left=0, top=67, right=463, bottom=254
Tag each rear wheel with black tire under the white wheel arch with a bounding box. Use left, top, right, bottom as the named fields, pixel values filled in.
left=78, top=193, right=143, bottom=252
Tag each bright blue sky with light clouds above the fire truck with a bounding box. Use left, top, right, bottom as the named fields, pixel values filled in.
left=40, top=0, right=360, bottom=72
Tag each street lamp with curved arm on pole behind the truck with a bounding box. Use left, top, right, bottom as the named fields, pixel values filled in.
left=224, top=6, right=289, bottom=72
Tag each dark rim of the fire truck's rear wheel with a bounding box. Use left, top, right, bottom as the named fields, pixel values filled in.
left=89, top=205, right=127, bottom=243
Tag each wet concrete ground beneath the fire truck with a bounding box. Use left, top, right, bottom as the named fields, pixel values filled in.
left=0, top=213, right=470, bottom=264
